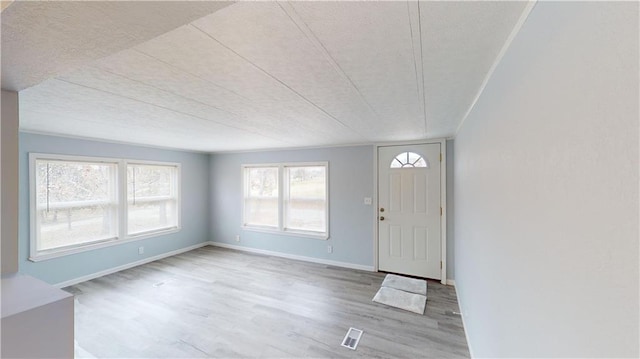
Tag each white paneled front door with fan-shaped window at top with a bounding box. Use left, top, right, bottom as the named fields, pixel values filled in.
left=378, top=143, right=441, bottom=279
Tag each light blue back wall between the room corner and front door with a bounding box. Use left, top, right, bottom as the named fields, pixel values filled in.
left=210, top=146, right=375, bottom=266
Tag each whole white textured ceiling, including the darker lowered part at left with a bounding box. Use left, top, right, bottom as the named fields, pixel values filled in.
left=2, top=2, right=526, bottom=152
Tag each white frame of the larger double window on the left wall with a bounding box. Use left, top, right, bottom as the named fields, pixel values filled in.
left=29, top=152, right=182, bottom=262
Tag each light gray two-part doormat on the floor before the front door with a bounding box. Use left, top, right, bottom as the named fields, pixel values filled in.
left=373, top=274, right=427, bottom=315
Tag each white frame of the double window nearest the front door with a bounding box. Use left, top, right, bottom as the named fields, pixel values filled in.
left=241, top=161, right=331, bottom=240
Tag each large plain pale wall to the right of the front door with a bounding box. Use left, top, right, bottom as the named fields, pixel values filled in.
left=454, top=2, right=640, bottom=358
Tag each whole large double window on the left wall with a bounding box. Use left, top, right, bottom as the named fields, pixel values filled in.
left=29, top=153, right=180, bottom=261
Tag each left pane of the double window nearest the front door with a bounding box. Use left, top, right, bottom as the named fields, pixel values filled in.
left=244, top=167, right=278, bottom=227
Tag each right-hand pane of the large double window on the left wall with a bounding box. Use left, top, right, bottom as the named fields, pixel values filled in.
left=127, top=164, right=178, bottom=234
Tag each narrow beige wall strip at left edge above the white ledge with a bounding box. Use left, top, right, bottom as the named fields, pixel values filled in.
left=0, top=90, right=18, bottom=274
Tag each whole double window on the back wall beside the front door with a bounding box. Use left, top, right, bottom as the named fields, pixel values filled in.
left=243, top=162, right=329, bottom=239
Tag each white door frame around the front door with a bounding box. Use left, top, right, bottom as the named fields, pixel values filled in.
left=373, top=138, right=447, bottom=284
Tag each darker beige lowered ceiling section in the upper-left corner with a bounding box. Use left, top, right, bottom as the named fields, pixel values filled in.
left=2, top=1, right=231, bottom=91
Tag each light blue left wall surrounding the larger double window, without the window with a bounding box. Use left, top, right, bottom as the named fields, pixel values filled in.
left=19, top=133, right=209, bottom=284
